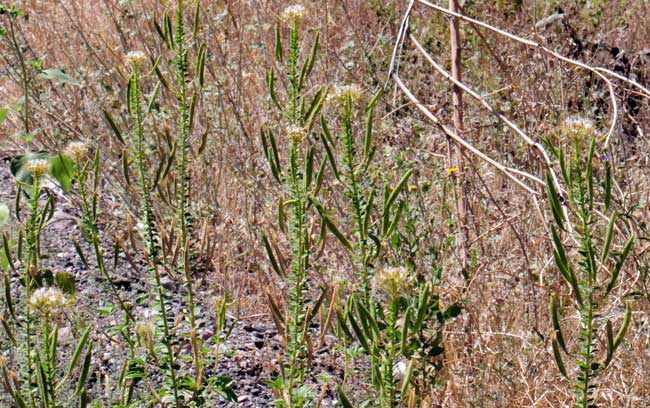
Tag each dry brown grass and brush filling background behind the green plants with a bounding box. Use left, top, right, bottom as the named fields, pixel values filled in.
left=0, top=0, right=650, bottom=407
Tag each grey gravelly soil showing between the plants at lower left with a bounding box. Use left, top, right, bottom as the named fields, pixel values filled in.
left=0, top=152, right=350, bottom=407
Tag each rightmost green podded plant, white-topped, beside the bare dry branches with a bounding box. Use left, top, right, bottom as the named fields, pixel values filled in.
left=546, top=119, right=634, bottom=408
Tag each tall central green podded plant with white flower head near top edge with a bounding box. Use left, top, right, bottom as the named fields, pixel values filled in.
left=261, top=4, right=325, bottom=407
